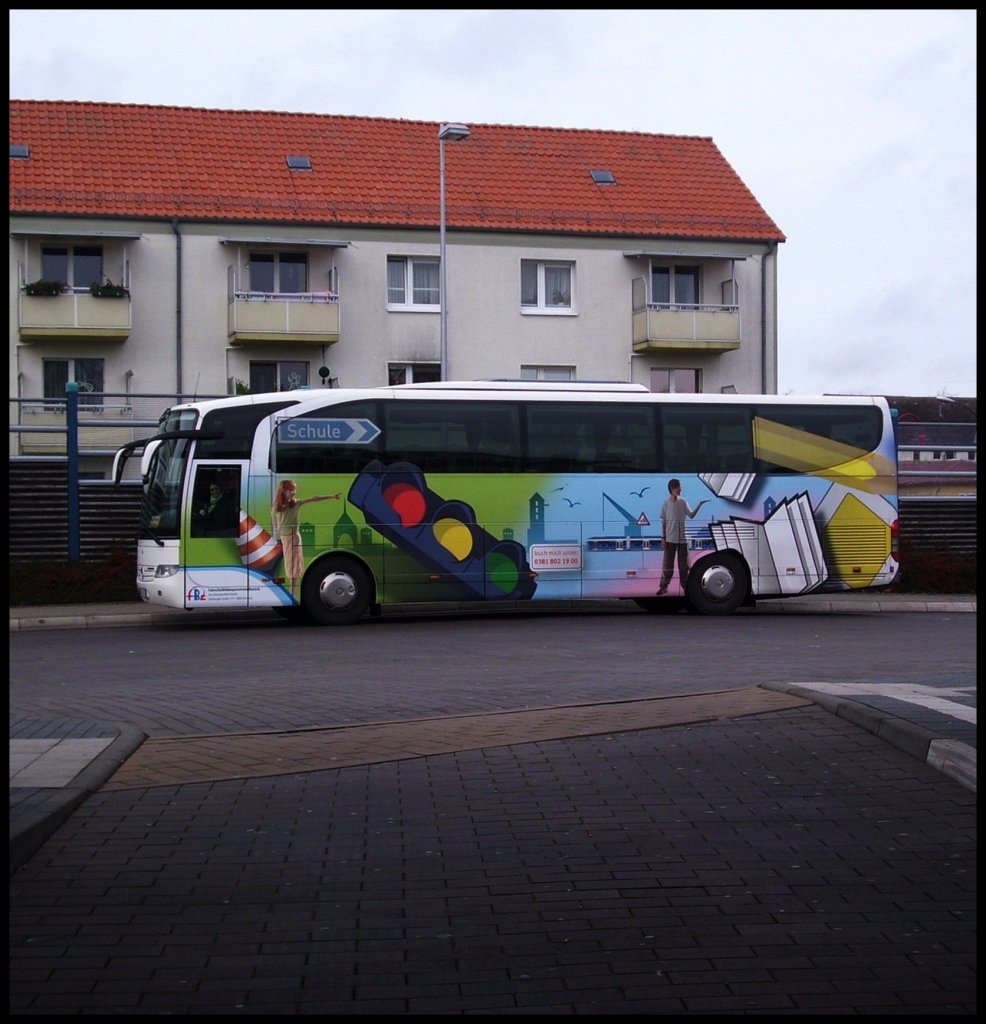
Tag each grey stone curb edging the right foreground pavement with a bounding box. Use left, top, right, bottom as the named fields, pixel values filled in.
left=760, top=683, right=976, bottom=793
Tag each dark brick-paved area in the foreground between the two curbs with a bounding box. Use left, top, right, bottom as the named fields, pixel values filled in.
left=9, top=706, right=977, bottom=1015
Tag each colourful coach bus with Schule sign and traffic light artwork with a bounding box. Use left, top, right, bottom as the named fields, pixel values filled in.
left=114, top=381, right=898, bottom=625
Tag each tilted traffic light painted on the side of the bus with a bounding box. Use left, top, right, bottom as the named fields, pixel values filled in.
left=349, top=461, right=538, bottom=600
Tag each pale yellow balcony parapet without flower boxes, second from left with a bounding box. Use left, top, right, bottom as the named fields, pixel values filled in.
left=227, top=292, right=339, bottom=345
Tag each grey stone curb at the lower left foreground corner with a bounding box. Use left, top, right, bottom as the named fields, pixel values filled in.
left=9, top=725, right=147, bottom=874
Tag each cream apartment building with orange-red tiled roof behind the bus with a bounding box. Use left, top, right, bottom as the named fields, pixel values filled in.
left=9, top=100, right=784, bottom=473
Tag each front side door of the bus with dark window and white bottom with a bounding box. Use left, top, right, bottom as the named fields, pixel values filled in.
left=181, top=459, right=250, bottom=608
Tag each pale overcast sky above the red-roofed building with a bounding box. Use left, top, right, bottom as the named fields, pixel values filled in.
left=10, top=8, right=977, bottom=397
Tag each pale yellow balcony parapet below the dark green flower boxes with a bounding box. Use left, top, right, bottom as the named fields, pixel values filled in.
left=17, top=288, right=131, bottom=341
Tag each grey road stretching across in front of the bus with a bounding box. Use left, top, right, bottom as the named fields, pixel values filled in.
left=9, top=612, right=976, bottom=736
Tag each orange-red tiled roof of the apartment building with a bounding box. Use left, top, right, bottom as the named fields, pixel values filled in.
left=9, top=99, right=784, bottom=242
